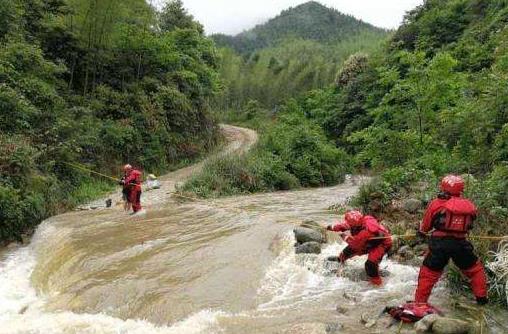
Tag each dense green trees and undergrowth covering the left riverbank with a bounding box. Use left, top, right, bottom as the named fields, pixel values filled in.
left=0, top=0, right=219, bottom=244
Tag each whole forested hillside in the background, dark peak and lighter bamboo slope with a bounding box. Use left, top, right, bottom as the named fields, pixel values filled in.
left=212, top=1, right=388, bottom=109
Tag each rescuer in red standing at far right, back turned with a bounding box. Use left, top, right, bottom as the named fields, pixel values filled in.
left=415, top=175, right=488, bottom=305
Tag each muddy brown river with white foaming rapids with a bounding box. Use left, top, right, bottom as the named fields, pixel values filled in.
left=0, top=126, right=506, bottom=334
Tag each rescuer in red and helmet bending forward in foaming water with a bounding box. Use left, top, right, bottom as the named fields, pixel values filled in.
left=327, top=211, right=392, bottom=286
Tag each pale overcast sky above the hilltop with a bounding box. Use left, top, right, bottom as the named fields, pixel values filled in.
left=148, top=0, right=423, bottom=34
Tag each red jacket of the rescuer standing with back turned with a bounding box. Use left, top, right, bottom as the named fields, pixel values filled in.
left=420, top=196, right=477, bottom=239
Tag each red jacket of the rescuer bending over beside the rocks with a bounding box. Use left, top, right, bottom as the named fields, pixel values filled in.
left=332, top=216, right=392, bottom=253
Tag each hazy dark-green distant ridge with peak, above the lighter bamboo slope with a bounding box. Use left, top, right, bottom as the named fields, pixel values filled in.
left=212, top=1, right=386, bottom=53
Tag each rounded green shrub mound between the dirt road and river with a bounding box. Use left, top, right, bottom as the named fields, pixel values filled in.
left=181, top=114, right=351, bottom=197
